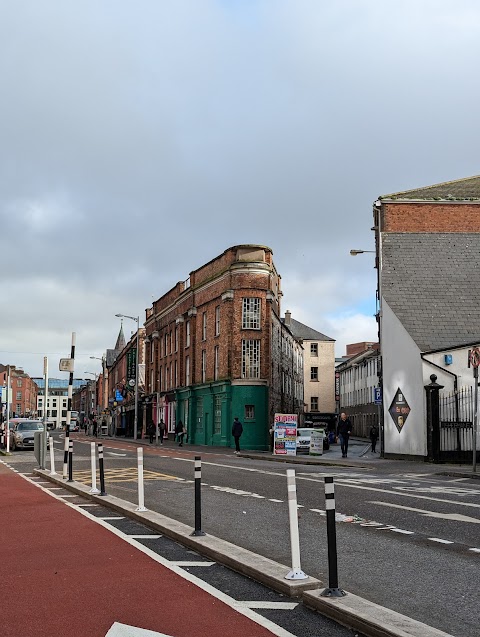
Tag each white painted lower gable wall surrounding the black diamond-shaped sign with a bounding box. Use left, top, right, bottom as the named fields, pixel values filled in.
left=381, top=299, right=431, bottom=456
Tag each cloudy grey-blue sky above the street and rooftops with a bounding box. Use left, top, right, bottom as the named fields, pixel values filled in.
left=0, top=0, right=480, bottom=378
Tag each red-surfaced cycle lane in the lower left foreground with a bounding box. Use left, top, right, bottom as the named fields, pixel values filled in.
left=0, top=464, right=278, bottom=637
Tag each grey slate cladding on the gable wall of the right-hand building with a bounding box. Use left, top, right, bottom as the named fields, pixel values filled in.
left=381, top=233, right=480, bottom=352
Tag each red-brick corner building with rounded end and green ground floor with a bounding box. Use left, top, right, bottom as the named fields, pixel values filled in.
left=145, top=245, right=303, bottom=449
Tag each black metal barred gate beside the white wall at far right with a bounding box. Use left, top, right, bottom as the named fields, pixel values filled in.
left=439, top=387, right=478, bottom=463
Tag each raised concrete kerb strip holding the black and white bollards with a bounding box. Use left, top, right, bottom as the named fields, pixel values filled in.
left=34, top=469, right=452, bottom=637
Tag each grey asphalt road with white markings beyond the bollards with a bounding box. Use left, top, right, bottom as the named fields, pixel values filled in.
left=4, top=436, right=480, bottom=637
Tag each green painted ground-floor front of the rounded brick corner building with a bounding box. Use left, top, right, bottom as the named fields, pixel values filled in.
left=175, top=382, right=268, bottom=450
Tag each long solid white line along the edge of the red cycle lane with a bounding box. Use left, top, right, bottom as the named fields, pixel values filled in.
left=22, top=476, right=295, bottom=637
